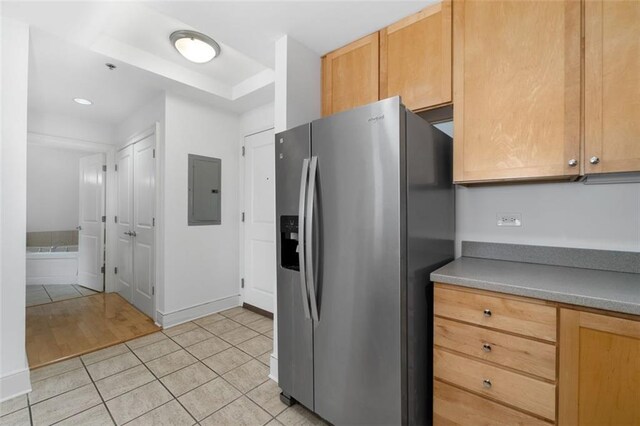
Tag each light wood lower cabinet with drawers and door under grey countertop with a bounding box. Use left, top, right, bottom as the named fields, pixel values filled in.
left=433, top=284, right=640, bottom=426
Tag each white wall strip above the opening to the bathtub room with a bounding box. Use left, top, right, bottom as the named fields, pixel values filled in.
left=28, top=110, right=115, bottom=144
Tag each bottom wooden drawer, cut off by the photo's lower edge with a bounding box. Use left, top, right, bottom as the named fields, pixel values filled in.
left=433, top=380, right=549, bottom=426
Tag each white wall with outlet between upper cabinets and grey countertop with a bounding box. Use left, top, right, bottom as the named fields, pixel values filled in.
left=456, top=182, right=640, bottom=256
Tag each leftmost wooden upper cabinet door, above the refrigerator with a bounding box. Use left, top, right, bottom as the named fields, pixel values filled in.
left=322, top=32, right=379, bottom=116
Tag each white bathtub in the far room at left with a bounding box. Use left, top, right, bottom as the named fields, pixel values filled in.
left=27, top=246, right=78, bottom=285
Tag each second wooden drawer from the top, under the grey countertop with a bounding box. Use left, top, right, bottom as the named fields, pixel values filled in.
left=434, top=317, right=556, bottom=381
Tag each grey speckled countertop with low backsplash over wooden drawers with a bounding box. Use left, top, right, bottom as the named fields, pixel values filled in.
left=431, top=241, right=640, bottom=315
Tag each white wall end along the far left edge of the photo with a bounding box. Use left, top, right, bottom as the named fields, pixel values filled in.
left=0, top=17, right=31, bottom=401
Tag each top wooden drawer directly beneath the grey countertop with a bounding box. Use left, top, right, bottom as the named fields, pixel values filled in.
left=434, top=286, right=556, bottom=342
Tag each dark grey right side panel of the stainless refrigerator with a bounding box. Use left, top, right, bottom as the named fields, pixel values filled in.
left=405, top=112, right=455, bottom=424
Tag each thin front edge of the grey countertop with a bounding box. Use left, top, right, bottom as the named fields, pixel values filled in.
left=431, top=272, right=640, bottom=315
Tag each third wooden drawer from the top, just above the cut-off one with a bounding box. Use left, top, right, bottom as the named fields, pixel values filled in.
left=433, top=348, right=556, bottom=420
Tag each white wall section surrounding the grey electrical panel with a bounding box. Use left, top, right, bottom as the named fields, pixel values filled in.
left=160, top=95, right=240, bottom=318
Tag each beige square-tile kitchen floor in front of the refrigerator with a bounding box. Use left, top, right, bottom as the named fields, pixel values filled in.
left=0, top=308, right=325, bottom=426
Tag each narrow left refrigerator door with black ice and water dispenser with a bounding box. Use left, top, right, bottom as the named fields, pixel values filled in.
left=275, top=125, right=314, bottom=410
